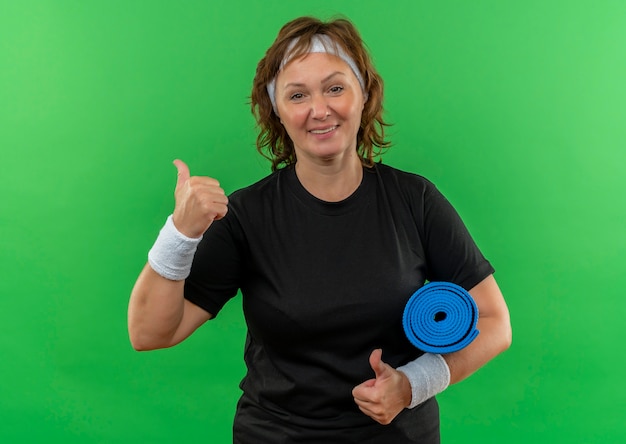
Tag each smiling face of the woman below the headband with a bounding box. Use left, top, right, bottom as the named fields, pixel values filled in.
left=276, top=53, right=365, bottom=166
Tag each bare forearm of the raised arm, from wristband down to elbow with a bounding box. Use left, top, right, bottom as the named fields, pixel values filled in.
left=128, top=264, right=185, bottom=350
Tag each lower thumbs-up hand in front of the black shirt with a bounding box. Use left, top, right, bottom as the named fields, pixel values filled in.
left=352, top=349, right=411, bottom=425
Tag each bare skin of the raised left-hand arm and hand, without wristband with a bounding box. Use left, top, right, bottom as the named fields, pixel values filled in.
left=128, top=160, right=228, bottom=350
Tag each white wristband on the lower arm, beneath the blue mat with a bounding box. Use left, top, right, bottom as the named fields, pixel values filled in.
left=396, top=353, right=450, bottom=409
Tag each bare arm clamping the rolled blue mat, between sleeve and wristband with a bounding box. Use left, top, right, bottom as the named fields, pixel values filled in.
left=443, top=275, right=512, bottom=384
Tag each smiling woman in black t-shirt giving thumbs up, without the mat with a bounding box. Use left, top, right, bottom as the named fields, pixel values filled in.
left=129, top=17, right=511, bottom=443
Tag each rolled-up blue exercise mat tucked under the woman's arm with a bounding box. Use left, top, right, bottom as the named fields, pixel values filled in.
left=402, top=282, right=478, bottom=354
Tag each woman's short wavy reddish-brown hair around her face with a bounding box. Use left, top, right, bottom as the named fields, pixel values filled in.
left=250, top=17, right=391, bottom=171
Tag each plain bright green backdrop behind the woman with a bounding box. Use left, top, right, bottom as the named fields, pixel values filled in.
left=0, top=0, right=626, bottom=443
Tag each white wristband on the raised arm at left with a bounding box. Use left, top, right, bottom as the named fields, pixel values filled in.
left=148, top=215, right=202, bottom=281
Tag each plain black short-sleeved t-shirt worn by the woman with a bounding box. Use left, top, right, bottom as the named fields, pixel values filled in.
left=185, top=164, right=493, bottom=444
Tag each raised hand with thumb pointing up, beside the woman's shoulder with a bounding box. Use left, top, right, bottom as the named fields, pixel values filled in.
left=173, top=159, right=228, bottom=238
